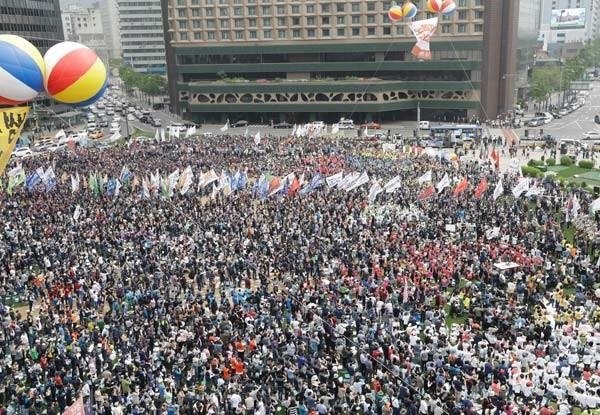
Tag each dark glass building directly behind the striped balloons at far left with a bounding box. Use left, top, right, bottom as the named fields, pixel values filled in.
left=0, top=0, right=64, bottom=54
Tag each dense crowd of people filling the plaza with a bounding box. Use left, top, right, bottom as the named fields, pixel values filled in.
left=0, top=131, right=600, bottom=415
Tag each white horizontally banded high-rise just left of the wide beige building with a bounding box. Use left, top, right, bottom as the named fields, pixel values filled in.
left=117, top=0, right=166, bottom=74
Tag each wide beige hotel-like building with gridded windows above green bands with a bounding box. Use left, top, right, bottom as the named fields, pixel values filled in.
left=162, top=0, right=518, bottom=122
